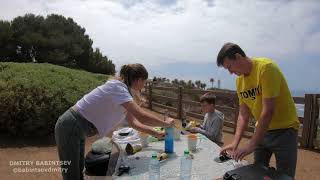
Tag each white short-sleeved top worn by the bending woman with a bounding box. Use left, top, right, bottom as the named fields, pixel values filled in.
left=76, top=80, right=133, bottom=136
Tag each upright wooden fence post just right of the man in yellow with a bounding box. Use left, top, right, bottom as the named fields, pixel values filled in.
left=301, top=94, right=313, bottom=148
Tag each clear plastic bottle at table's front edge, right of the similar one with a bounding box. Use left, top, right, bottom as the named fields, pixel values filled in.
left=180, top=150, right=192, bottom=180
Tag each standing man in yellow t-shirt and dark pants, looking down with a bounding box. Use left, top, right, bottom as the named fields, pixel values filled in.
left=217, top=43, right=300, bottom=177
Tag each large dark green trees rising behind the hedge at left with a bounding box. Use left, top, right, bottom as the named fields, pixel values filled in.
left=0, top=14, right=115, bottom=75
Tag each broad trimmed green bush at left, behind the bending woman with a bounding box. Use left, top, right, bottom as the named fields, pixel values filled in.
left=0, top=63, right=108, bottom=136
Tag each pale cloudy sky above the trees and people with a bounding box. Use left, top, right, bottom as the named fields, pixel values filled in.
left=0, top=0, right=320, bottom=92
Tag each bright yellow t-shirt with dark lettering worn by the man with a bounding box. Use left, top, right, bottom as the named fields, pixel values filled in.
left=236, top=58, right=300, bottom=130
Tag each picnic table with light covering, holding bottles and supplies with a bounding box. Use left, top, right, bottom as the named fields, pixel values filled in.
left=112, top=134, right=247, bottom=180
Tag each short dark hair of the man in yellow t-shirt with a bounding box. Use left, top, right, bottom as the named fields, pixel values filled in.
left=217, top=42, right=246, bottom=67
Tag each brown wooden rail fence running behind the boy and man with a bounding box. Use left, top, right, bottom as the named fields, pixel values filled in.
left=142, top=83, right=320, bottom=149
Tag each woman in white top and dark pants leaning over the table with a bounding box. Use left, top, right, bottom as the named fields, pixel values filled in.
left=55, top=64, right=174, bottom=180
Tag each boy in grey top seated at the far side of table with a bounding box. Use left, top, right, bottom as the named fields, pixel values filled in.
left=190, top=92, right=224, bottom=146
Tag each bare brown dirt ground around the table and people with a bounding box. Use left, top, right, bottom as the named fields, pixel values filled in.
left=0, top=109, right=320, bottom=180
